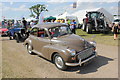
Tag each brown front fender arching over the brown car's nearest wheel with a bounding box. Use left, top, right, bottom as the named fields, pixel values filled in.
left=42, top=44, right=70, bottom=61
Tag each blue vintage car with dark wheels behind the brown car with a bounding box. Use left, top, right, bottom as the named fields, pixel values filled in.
left=8, top=26, right=29, bottom=43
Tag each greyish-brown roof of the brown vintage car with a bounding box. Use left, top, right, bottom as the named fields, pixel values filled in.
left=33, top=23, right=67, bottom=28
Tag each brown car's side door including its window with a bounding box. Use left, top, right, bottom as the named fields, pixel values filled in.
left=36, top=29, right=50, bottom=57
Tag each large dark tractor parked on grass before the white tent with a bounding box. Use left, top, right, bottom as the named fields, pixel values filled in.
left=82, top=11, right=110, bottom=34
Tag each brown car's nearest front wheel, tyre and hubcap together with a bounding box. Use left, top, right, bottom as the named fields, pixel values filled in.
left=54, top=54, right=67, bottom=70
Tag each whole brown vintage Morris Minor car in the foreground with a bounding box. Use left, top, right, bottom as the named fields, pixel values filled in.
left=24, top=23, right=97, bottom=70
